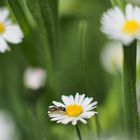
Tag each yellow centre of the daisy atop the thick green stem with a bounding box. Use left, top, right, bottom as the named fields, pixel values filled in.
left=122, top=20, right=140, bottom=35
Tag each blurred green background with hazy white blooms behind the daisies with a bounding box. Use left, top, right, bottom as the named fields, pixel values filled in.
left=0, top=0, right=140, bottom=140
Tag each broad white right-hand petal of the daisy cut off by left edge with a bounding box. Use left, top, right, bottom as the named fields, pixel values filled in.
left=3, top=25, right=23, bottom=44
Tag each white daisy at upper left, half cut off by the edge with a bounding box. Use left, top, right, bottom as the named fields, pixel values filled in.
left=0, top=8, right=23, bottom=53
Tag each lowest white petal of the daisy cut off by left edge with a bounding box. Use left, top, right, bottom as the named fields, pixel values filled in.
left=0, top=37, right=10, bottom=53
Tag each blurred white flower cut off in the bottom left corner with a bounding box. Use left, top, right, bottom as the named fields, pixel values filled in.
left=0, top=111, right=15, bottom=140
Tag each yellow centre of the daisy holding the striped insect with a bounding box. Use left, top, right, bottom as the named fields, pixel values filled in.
left=66, top=104, right=83, bottom=117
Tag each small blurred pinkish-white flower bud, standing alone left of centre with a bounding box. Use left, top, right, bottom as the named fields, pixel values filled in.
left=24, top=68, right=47, bottom=90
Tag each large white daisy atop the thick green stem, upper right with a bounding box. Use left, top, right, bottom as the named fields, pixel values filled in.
left=101, top=4, right=140, bottom=45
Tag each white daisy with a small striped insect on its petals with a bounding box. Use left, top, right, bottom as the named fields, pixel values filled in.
left=48, top=93, right=97, bottom=125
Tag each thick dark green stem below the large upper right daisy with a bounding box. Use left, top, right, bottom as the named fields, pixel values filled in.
left=123, top=41, right=140, bottom=139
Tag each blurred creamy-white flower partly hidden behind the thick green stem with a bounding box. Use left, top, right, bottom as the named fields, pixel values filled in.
left=101, top=42, right=140, bottom=74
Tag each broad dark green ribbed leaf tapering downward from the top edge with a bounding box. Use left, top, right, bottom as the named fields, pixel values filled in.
left=38, top=0, right=59, bottom=57
